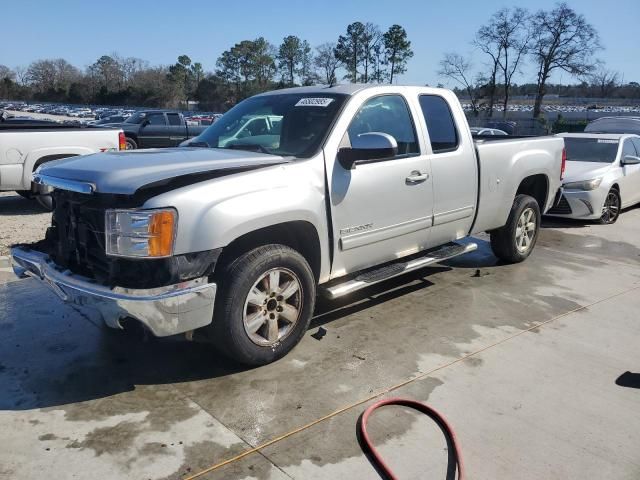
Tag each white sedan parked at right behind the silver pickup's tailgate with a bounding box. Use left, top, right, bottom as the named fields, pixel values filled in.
left=547, top=133, right=640, bottom=224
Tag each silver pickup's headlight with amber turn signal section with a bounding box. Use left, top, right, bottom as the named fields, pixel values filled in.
left=105, top=208, right=178, bottom=258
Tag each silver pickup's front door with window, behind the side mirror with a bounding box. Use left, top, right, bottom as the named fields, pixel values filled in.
left=329, top=94, right=433, bottom=277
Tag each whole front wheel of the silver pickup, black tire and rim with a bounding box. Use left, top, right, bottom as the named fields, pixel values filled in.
left=207, top=245, right=316, bottom=366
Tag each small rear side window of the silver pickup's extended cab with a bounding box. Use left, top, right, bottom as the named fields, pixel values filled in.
left=420, top=95, right=458, bottom=153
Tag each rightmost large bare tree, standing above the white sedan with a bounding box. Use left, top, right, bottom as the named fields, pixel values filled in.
left=531, top=3, right=601, bottom=117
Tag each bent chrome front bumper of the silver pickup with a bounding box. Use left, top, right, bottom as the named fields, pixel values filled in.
left=11, top=247, right=216, bottom=337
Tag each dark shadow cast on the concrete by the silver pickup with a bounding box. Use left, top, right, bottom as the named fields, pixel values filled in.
left=0, top=238, right=497, bottom=410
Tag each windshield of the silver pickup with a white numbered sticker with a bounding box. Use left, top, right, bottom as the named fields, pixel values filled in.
left=193, top=93, right=347, bottom=158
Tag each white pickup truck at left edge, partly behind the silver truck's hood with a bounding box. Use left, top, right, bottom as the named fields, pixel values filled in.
left=0, top=119, right=125, bottom=209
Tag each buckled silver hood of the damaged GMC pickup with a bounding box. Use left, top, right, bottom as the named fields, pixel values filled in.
left=38, top=147, right=288, bottom=195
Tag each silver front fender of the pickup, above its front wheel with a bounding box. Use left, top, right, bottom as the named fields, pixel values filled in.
left=144, top=160, right=329, bottom=274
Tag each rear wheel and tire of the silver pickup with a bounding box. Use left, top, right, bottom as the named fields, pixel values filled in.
left=491, top=195, right=541, bottom=263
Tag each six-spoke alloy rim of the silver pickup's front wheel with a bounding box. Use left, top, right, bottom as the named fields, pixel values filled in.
left=243, top=268, right=303, bottom=346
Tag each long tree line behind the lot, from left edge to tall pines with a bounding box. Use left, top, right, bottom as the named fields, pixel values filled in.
left=0, top=22, right=413, bottom=111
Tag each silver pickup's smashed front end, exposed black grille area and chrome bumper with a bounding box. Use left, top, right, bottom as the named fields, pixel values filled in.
left=11, top=190, right=220, bottom=336
